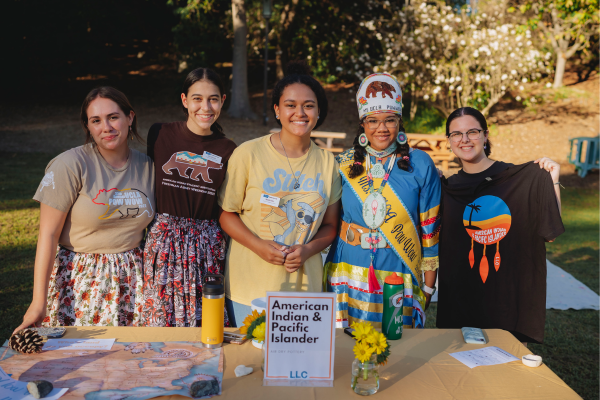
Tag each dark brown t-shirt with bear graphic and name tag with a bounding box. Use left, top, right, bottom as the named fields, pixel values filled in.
left=148, top=121, right=236, bottom=220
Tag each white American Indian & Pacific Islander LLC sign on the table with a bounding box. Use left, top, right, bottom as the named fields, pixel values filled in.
left=263, top=292, right=335, bottom=386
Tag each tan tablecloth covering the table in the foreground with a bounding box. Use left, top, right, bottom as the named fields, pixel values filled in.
left=12, top=327, right=580, bottom=400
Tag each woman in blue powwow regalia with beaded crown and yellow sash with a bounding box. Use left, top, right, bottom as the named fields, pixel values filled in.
left=325, top=74, right=440, bottom=328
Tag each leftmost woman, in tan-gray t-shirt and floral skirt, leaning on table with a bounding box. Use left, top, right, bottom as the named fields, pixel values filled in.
left=15, top=87, right=155, bottom=331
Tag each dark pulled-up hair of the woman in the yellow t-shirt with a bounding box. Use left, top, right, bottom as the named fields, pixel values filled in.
left=271, top=61, right=329, bottom=129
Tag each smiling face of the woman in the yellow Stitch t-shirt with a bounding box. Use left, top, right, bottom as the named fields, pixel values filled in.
left=274, top=83, right=319, bottom=136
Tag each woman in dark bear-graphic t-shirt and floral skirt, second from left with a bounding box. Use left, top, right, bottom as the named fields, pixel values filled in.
left=141, top=68, right=236, bottom=326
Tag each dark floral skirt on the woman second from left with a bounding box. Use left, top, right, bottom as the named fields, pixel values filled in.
left=141, top=214, right=229, bottom=327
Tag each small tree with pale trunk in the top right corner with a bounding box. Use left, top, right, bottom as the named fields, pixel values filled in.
left=509, top=0, right=599, bottom=88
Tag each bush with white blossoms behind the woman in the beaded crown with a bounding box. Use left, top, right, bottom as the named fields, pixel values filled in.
left=376, top=0, right=549, bottom=117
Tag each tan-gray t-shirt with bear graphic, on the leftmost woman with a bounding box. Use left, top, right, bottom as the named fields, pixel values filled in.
left=33, top=144, right=156, bottom=254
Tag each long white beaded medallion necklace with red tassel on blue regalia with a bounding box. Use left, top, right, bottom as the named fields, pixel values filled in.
left=360, top=154, right=396, bottom=292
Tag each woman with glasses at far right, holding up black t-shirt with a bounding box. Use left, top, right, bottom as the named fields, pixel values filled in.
left=437, top=107, right=564, bottom=343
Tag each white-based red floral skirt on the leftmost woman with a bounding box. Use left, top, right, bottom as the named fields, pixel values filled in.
left=42, top=246, right=143, bottom=327
